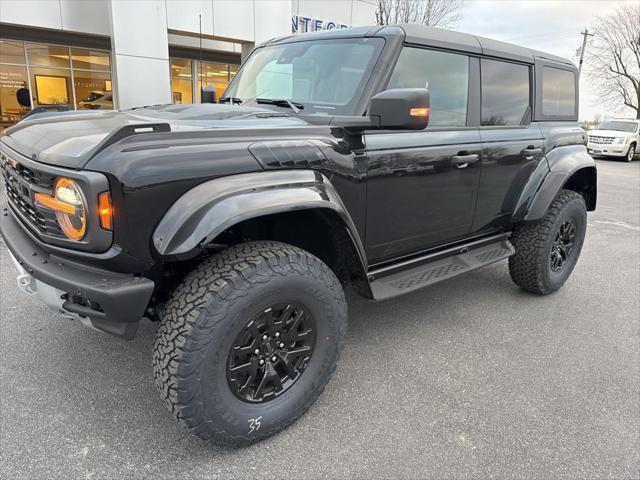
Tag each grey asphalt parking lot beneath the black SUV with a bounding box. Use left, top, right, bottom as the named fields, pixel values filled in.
left=0, top=161, right=640, bottom=479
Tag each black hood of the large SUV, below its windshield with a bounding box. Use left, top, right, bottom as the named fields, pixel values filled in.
left=0, top=104, right=308, bottom=168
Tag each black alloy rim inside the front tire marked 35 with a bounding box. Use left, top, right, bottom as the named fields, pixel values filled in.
left=227, top=302, right=316, bottom=403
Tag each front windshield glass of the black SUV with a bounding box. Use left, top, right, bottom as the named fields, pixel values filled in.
left=223, top=38, right=384, bottom=115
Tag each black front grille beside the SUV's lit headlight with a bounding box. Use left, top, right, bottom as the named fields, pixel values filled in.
left=0, top=153, right=65, bottom=238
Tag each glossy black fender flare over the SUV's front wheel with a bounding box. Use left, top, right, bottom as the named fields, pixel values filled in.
left=152, top=170, right=367, bottom=271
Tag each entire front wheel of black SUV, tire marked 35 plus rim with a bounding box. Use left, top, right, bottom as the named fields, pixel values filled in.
left=153, top=242, right=347, bottom=446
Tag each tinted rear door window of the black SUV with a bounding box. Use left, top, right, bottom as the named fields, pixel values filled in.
left=480, top=58, right=530, bottom=125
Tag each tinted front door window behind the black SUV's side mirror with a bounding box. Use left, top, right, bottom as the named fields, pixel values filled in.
left=388, top=47, right=469, bottom=127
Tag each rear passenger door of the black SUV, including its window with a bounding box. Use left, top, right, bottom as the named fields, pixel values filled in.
left=472, top=58, right=544, bottom=232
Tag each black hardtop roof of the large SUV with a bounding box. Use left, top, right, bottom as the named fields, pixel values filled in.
left=266, top=24, right=575, bottom=69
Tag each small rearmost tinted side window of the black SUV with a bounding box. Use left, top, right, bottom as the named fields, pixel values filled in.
left=542, top=67, right=576, bottom=115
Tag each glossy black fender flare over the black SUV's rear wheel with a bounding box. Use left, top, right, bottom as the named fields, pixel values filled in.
left=512, top=145, right=597, bottom=222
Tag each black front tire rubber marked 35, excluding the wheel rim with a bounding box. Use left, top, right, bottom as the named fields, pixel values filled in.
left=153, top=241, right=347, bottom=447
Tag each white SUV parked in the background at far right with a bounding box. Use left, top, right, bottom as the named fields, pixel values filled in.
left=587, top=120, right=640, bottom=162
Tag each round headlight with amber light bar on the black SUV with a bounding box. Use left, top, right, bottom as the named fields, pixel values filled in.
left=35, top=177, right=87, bottom=241
